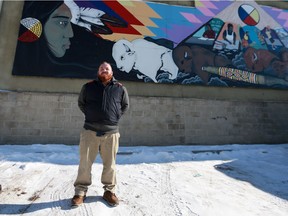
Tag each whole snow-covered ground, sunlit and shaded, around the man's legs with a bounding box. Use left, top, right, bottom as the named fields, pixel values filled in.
left=0, top=144, right=288, bottom=216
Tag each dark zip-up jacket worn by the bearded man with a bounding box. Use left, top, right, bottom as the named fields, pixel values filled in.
left=78, top=78, right=129, bottom=133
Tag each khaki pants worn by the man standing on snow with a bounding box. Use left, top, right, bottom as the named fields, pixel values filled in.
left=74, top=130, right=120, bottom=196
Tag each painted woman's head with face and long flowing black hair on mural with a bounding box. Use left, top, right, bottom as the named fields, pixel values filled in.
left=12, top=1, right=115, bottom=78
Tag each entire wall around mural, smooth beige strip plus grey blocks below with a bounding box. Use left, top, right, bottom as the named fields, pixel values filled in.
left=0, top=1, right=288, bottom=145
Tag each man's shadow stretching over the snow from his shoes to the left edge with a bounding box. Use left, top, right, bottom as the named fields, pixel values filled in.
left=0, top=196, right=112, bottom=215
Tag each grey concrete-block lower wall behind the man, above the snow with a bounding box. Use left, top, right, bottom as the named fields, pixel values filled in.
left=0, top=91, right=288, bottom=146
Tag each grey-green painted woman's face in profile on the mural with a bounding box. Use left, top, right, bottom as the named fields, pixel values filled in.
left=44, top=3, right=74, bottom=58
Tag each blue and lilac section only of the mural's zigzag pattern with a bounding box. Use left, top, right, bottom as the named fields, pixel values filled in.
left=147, top=0, right=232, bottom=44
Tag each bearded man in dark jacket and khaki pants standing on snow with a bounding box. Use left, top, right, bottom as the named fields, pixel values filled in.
left=71, top=62, right=129, bottom=207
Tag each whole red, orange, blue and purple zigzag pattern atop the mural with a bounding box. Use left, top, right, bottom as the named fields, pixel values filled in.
left=90, top=0, right=232, bottom=44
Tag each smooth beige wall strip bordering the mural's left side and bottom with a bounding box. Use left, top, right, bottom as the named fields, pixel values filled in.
left=0, top=1, right=287, bottom=96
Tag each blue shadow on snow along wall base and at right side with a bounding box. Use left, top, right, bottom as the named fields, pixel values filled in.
left=0, top=144, right=288, bottom=203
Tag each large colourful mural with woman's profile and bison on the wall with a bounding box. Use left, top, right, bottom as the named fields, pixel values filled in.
left=12, top=0, right=288, bottom=89
